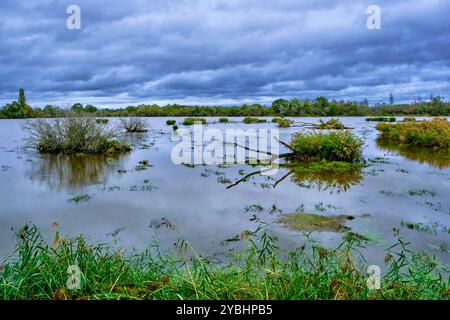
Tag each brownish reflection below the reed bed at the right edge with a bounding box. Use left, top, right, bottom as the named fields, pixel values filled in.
left=377, top=139, right=450, bottom=169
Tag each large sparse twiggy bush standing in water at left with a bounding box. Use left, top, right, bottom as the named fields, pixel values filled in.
left=25, top=117, right=131, bottom=154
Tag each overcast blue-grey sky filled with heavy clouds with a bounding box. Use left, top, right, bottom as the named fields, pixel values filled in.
left=0, top=0, right=450, bottom=106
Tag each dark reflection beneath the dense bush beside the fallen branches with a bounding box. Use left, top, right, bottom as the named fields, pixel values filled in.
left=290, top=166, right=363, bottom=192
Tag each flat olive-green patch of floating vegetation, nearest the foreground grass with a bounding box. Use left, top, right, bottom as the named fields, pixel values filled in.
left=279, top=212, right=354, bottom=232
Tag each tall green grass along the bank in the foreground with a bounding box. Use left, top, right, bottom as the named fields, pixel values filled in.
left=0, top=227, right=450, bottom=300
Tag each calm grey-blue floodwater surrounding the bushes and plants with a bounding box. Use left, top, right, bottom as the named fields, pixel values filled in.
left=0, top=117, right=450, bottom=265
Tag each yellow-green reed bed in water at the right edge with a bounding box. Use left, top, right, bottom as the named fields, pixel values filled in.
left=376, top=118, right=450, bottom=151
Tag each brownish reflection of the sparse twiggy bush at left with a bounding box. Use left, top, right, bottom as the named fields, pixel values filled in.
left=26, top=154, right=123, bottom=190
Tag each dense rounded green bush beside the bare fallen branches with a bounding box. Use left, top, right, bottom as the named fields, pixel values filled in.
left=290, top=131, right=363, bottom=163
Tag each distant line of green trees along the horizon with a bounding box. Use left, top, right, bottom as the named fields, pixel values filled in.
left=0, top=89, right=450, bottom=119
